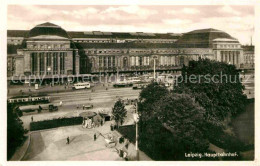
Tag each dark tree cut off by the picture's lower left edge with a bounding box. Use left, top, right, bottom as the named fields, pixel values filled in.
left=7, top=104, right=25, bottom=160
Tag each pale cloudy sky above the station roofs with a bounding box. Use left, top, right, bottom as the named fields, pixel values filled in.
left=7, top=5, right=254, bottom=44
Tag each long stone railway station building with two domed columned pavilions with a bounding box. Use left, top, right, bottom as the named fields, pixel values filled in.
left=7, top=22, right=249, bottom=81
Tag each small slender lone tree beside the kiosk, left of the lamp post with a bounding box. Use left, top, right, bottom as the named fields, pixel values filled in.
left=112, top=99, right=127, bottom=126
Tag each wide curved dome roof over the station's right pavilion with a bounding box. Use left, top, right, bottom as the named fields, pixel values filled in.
left=176, top=28, right=238, bottom=48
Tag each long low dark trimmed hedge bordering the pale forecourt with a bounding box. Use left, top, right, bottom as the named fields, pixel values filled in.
left=30, top=117, right=82, bottom=131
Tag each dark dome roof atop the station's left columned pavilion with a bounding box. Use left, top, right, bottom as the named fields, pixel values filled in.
left=29, top=22, right=70, bottom=38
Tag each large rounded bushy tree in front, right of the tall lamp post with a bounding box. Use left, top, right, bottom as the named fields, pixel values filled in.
left=140, top=93, right=209, bottom=160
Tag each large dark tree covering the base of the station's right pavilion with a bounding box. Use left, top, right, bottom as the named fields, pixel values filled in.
left=173, top=59, right=246, bottom=124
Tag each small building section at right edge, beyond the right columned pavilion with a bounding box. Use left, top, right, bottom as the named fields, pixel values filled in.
left=242, top=45, right=255, bottom=69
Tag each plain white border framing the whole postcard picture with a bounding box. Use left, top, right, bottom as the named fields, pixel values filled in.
left=0, top=0, right=260, bottom=166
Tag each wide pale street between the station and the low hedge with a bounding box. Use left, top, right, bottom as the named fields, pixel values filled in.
left=20, top=87, right=140, bottom=129
